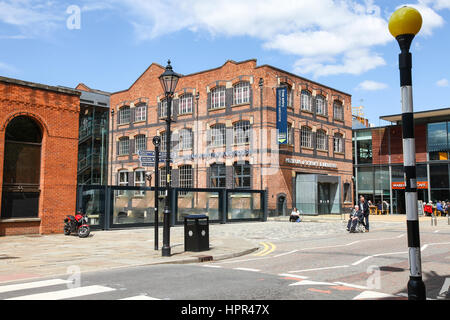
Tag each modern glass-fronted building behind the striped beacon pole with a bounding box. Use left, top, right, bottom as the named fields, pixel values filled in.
left=352, top=108, right=450, bottom=214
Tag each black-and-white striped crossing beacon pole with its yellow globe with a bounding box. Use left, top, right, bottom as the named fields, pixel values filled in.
left=389, top=6, right=426, bottom=300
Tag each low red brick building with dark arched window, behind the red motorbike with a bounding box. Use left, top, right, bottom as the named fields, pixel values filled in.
left=0, top=77, right=80, bottom=236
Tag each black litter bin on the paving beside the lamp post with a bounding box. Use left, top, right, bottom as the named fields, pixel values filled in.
left=184, top=214, right=209, bottom=252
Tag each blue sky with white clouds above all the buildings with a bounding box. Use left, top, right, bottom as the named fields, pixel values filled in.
left=0, top=0, right=450, bottom=126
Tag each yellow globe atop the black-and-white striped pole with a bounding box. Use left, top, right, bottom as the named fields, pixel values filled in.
left=389, top=6, right=422, bottom=38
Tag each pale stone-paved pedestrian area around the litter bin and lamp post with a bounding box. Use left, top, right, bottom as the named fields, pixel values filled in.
left=0, top=214, right=447, bottom=283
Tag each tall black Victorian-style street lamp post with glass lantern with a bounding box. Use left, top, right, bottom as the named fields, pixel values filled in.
left=159, top=60, right=181, bottom=257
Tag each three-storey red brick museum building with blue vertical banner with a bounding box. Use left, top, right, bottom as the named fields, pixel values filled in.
left=109, top=60, right=353, bottom=215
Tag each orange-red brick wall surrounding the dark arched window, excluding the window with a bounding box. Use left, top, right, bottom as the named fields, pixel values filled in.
left=0, top=78, right=80, bottom=235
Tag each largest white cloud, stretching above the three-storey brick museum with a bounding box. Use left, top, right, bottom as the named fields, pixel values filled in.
left=110, top=0, right=393, bottom=77
